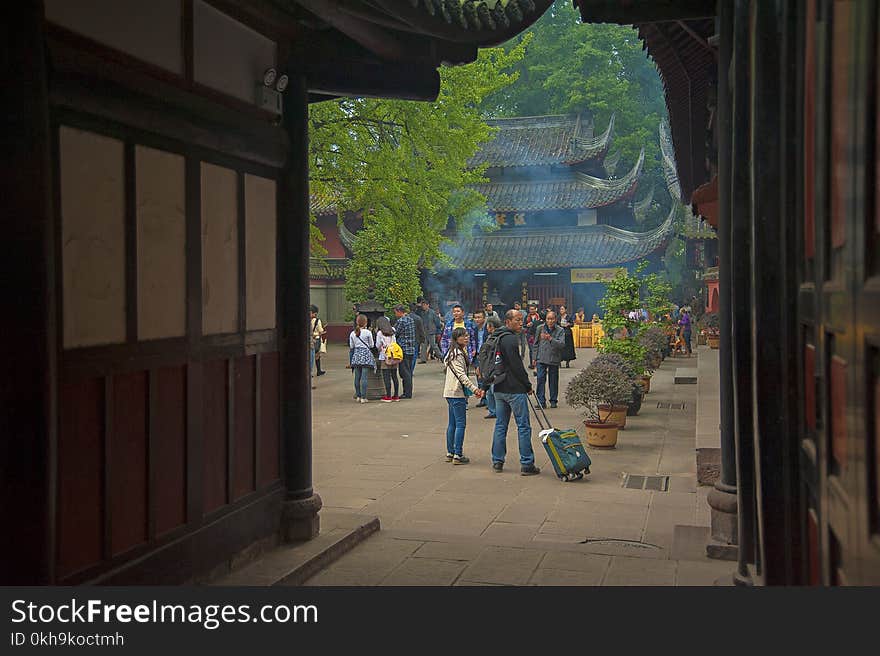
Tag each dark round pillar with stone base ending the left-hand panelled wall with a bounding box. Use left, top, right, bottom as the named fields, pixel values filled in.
left=277, top=74, right=321, bottom=542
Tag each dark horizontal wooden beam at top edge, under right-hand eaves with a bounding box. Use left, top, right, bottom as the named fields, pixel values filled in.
left=575, top=0, right=716, bottom=25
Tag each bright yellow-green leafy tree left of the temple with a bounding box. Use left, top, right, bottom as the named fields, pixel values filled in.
left=309, top=39, right=529, bottom=306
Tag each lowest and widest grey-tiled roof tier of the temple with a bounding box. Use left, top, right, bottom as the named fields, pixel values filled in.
left=444, top=213, right=674, bottom=271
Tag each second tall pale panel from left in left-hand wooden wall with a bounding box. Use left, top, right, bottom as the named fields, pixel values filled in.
left=135, top=146, right=186, bottom=339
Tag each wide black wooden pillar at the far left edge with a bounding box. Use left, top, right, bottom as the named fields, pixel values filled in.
left=0, top=0, right=57, bottom=585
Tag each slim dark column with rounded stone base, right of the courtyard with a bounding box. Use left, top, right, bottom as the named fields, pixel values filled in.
left=706, top=0, right=738, bottom=560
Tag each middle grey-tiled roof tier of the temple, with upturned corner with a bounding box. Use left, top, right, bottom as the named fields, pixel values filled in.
left=475, top=150, right=645, bottom=212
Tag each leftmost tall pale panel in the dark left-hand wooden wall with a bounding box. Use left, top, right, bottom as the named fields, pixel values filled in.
left=59, top=126, right=125, bottom=348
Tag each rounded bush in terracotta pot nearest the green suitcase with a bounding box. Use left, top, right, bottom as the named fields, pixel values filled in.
left=565, top=362, right=632, bottom=447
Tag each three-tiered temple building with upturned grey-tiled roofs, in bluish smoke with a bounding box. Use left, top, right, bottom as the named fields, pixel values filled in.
left=423, top=115, right=674, bottom=315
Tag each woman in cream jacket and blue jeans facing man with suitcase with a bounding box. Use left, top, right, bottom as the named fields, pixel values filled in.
left=443, top=328, right=483, bottom=465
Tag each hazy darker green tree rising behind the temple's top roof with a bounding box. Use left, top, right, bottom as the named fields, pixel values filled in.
left=483, top=0, right=669, bottom=218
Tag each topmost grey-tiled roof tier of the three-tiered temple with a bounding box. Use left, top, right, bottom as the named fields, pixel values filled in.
left=469, top=114, right=614, bottom=167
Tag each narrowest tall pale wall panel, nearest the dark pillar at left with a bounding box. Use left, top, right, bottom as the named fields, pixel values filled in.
left=244, top=175, right=275, bottom=330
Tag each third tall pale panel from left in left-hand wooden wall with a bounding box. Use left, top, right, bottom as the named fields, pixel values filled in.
left=201, top=162, right=238, bottom=335
